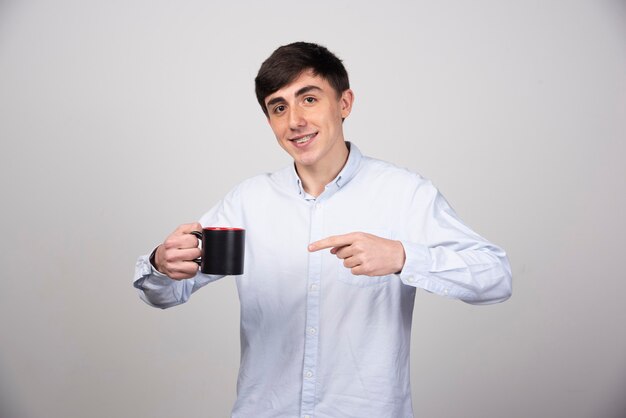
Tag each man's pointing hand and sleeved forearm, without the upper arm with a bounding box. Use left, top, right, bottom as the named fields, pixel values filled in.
left=309, top=232, right=511, bottom=304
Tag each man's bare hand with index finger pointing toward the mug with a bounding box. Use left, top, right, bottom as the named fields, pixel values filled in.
left=309, top=232, right=406, bottom=276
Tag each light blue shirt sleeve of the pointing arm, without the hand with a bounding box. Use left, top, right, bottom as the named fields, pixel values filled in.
left=400, top=183, right=512, bottom=304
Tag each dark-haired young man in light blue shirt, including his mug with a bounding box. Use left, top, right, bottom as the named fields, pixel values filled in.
left=135, top=42, right=511, bottom=418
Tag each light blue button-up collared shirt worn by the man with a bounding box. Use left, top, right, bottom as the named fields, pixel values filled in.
left=134, top=144, right=511, bottom=418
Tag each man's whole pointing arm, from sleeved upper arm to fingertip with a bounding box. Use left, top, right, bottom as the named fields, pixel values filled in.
left=309, top=185, right=512, bottom=304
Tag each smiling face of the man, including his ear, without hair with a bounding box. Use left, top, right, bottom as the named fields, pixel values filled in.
left=265, top=71, right=353, bottom=170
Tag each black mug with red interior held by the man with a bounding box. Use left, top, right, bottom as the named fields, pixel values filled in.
left=191, top=227, right=246, bottom=276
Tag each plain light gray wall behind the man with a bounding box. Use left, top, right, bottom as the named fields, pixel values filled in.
left=0, top=0, right=626, bottom=418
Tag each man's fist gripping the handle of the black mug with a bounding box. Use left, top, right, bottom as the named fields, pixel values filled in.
left=154, top=222, right=202, bottom=280
